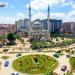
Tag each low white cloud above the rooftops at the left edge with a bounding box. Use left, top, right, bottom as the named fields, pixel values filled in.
left=0, top=13, right=25, bottom=24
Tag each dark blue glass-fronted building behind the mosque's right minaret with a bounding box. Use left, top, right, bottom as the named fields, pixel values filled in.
left=42, top=19, right=62, bottom=33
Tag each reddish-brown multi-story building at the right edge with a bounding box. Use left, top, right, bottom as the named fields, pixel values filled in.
left=62, top=22, right=75, bottom=34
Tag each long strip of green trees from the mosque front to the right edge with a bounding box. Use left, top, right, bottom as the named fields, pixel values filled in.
left=30, top=37, right=75, bottom=49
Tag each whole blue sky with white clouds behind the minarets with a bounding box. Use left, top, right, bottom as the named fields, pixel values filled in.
left=0, top=0, right=75, bottom=24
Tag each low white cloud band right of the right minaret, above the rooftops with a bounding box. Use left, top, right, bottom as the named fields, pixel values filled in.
left=52, top=10, right=75, bottom=22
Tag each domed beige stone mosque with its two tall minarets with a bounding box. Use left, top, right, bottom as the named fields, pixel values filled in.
left=28, top=5, right=50, bottom=41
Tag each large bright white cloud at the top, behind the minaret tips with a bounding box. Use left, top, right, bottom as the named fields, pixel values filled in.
left=26, top=0, right=66, bottom=10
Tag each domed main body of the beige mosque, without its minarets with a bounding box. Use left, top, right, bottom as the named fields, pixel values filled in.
left=28, top=21, right=50, bottom=41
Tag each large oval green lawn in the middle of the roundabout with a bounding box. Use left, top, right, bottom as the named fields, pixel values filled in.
left=13, top=54, right=58, bottom=74
